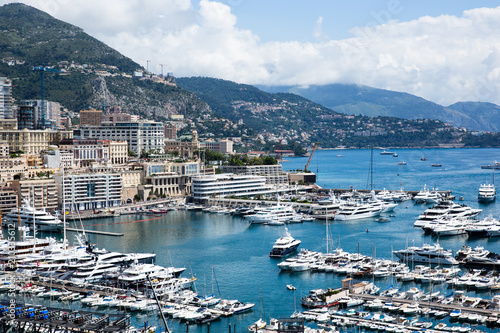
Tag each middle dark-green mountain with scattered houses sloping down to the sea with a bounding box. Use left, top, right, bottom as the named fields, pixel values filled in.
left=177, top=77, right=498, bottom=147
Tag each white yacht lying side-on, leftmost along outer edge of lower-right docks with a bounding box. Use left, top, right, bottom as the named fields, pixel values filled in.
left=393, top=244, right=458, bottom=265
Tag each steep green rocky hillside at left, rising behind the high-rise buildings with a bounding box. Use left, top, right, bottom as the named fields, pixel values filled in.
left=0, top=3, right=211, bottom=120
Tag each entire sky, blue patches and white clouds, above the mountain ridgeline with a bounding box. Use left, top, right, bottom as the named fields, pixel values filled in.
left=0, top=0, right=500, bottom=105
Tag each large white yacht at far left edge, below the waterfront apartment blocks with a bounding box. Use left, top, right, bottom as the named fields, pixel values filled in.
left=2, top=199, right=63, bottom=232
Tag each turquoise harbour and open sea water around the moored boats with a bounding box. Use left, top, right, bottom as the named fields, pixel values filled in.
left=5, top=149, right=500, bottom=332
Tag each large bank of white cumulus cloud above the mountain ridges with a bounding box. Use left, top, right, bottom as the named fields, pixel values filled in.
left=0, top=0, right=500, bottom=105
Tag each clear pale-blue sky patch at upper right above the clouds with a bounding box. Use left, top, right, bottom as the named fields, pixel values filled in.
left=228, top=0, right=500, bottom=41
